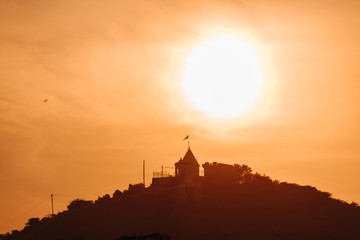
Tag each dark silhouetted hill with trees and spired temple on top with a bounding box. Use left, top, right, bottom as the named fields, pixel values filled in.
left=0, top=148, right=360, bottom=240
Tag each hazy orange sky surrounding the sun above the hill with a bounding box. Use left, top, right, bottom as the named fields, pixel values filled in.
left=0, top=0, right=360, bottom=233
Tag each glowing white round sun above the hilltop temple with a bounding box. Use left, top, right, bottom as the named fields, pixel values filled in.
left=181, top=35, right=264, bottom=118
